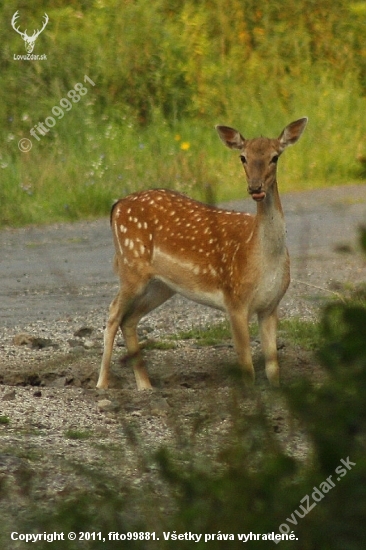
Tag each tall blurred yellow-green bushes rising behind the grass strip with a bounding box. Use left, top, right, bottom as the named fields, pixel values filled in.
left=0, top=0, right=366, bottom=123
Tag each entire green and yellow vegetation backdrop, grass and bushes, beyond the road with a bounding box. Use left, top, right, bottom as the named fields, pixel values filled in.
left=0, top=0, right=366, bottom=225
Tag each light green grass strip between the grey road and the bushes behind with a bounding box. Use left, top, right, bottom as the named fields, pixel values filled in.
left=0, top=75, right=366, bottom=226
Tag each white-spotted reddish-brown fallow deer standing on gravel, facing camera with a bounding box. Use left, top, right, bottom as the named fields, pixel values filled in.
left=97, top=118, right=308, bottom=390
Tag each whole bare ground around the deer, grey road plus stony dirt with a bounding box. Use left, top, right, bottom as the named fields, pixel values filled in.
left=0, top=185, right=366, bottom=536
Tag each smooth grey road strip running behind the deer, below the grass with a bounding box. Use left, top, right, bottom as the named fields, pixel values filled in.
left=0, top=185, right=366, bottom=329
